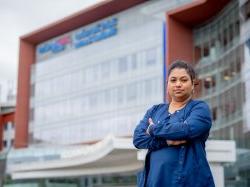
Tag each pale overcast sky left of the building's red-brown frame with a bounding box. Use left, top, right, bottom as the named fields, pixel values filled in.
left=0, top=0, right=103, bottom=80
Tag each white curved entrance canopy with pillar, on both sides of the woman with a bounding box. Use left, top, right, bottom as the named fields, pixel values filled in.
left=7, top=136, right=236, bottom=187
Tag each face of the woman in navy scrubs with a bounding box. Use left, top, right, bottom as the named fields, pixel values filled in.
left=167, top=68, right=194, bottom=101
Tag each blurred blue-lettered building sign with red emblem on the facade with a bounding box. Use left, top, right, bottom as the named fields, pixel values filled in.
left=37, top=18, right=117, bottom=60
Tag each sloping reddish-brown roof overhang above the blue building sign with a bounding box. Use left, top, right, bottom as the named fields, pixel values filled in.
left=20, top=0, right=147, bottom=44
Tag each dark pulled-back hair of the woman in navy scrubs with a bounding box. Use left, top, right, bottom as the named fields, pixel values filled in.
left=168, top=60, right=196, bottom=83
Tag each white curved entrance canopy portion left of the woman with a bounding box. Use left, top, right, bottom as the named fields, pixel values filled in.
left=7, top=136, right=143, bottom=179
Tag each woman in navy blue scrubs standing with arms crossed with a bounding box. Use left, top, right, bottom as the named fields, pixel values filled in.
left=133, top=61, right=215, bottom=187
